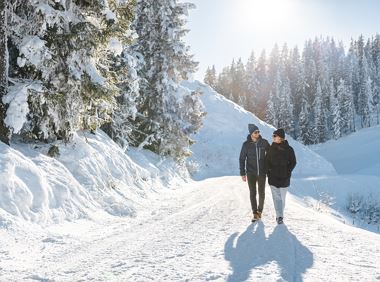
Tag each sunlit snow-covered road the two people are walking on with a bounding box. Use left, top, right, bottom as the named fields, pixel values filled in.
left=0, top=177, right=380, bottom=281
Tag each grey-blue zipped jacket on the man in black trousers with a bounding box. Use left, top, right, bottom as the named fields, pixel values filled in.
left=239, top=135, right=270, bottom=176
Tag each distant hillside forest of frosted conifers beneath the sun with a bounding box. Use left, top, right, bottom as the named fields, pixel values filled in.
left=204, top=35, right=380, bottom=144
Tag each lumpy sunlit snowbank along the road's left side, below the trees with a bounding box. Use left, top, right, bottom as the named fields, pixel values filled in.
left=0, top=131, right=186, bottom=225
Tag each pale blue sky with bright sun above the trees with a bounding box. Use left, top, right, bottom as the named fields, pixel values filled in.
left=185, top=0, right=380, bottom=79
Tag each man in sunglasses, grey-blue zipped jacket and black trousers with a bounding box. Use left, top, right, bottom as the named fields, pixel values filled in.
left=239, top=124, right=269, bottom=222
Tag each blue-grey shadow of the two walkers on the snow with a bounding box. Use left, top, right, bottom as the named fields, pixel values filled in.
left=224, top=222, right=313, bottom=282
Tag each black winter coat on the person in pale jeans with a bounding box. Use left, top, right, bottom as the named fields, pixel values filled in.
left=265, top=140, right=297, bottom=188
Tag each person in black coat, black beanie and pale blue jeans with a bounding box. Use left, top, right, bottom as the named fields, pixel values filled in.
left=265, top=128, right=297, bottom=224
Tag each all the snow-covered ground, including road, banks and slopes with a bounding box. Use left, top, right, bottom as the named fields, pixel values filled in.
left=0, top=82, right=380, bottom=281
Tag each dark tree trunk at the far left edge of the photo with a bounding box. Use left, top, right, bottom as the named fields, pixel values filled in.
left=0, top=0, right=9, bottom=144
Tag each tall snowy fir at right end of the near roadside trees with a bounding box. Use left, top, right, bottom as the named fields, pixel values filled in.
left=133, top=0, right=203, bottom=159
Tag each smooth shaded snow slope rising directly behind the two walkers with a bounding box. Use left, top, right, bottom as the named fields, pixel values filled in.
left=183, top=81, right=336, bottom=179
